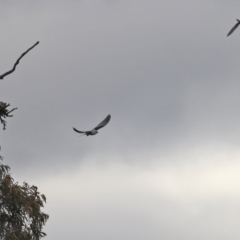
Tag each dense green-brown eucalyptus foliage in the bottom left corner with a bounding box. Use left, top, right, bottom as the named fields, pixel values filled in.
left=0, top=158, right=49, bottom=240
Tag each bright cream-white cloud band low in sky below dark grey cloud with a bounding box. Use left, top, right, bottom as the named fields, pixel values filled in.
left=34, top=143, right=240, bottom=239
